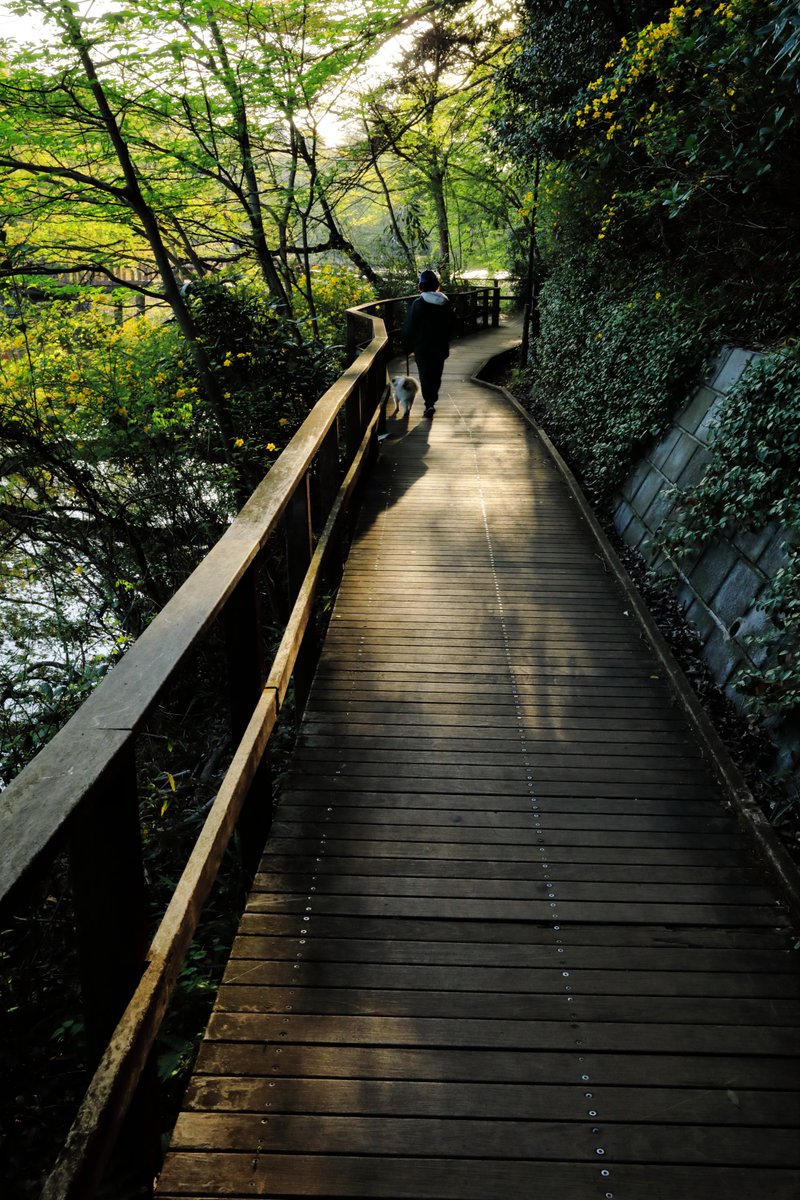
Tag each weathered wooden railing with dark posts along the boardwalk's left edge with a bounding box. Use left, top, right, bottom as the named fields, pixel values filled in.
left=0, top=287, right=499, bottom=1200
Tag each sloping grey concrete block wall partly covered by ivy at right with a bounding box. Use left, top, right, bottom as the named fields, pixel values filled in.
left=614, top=347, right=800, bottom=767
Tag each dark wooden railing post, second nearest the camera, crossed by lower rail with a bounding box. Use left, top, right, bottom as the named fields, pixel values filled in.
left=224, top=564, right=272, bottom=881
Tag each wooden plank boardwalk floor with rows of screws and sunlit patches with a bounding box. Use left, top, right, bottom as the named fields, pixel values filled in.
left=158, top=319, right=800, bottom=1200
